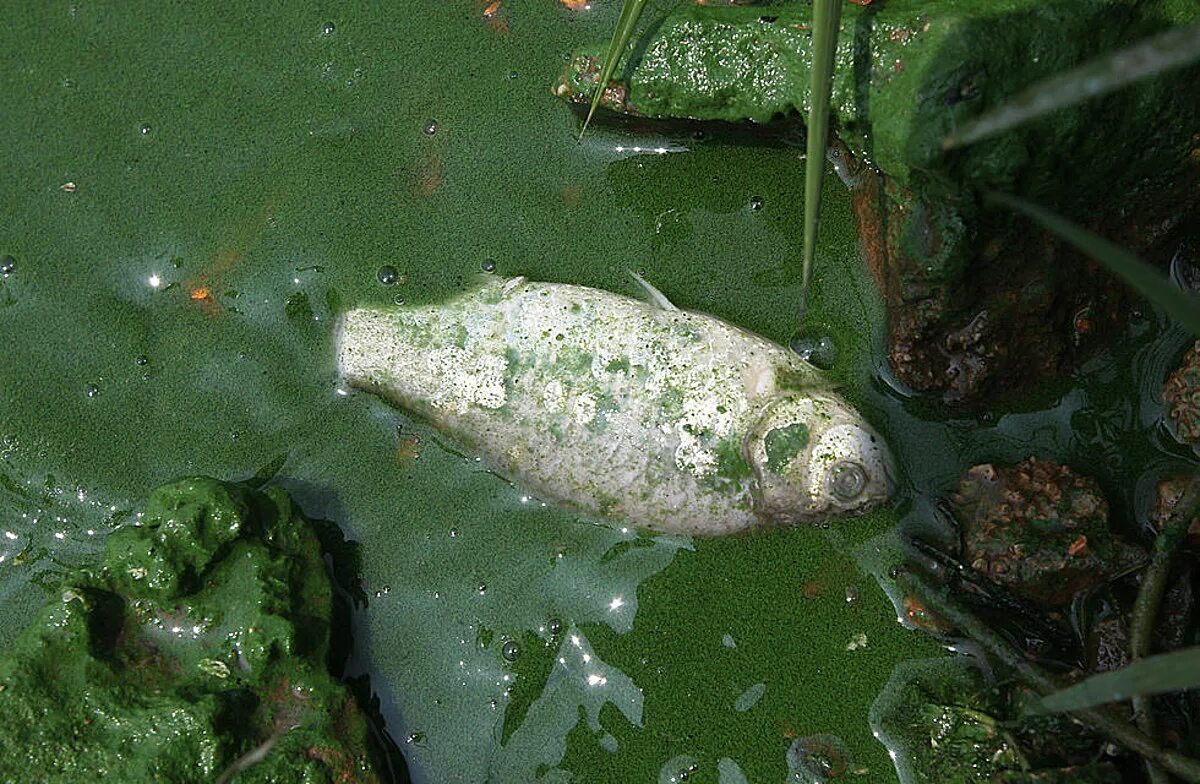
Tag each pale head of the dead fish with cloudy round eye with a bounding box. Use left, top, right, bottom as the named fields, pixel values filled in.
left=745, top=391, right=895, bottom=523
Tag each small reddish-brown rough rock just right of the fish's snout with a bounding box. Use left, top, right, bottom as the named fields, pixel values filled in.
left=952, top=457, right=1140, bottom=608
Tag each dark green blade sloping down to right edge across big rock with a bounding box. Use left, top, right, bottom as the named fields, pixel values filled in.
left=985, top=192, right=1200, bottom=337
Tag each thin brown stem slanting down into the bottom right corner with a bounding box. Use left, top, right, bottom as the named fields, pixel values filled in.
left=898, top=574, right=1200, bottom=784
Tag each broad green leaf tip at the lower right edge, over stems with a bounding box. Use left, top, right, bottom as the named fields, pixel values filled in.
left=1042, top=646, right=1200, bottom=712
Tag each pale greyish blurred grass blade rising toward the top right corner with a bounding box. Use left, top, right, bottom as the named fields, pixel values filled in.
left=942, top=24, right=1200, bottom=150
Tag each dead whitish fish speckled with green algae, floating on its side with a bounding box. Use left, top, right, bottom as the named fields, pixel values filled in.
left=337, top=272, right=893, bottom=535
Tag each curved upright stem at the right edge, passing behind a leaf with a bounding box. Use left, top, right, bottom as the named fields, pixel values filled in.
left=1129, top=478, right=1200, bottom=784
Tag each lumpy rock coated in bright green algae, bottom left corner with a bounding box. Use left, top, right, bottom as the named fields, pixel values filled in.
left=0, top=478, right=383, bottom=784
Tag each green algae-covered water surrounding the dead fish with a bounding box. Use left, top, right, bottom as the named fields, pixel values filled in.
left=0, top=0, right=1186, bottom=783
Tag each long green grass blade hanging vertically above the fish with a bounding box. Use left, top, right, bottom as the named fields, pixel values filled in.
left=800, top=0, right=841, bottom=319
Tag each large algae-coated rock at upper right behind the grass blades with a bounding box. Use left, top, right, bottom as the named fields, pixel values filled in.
left=554, top=0, right=1200, bottom=402
